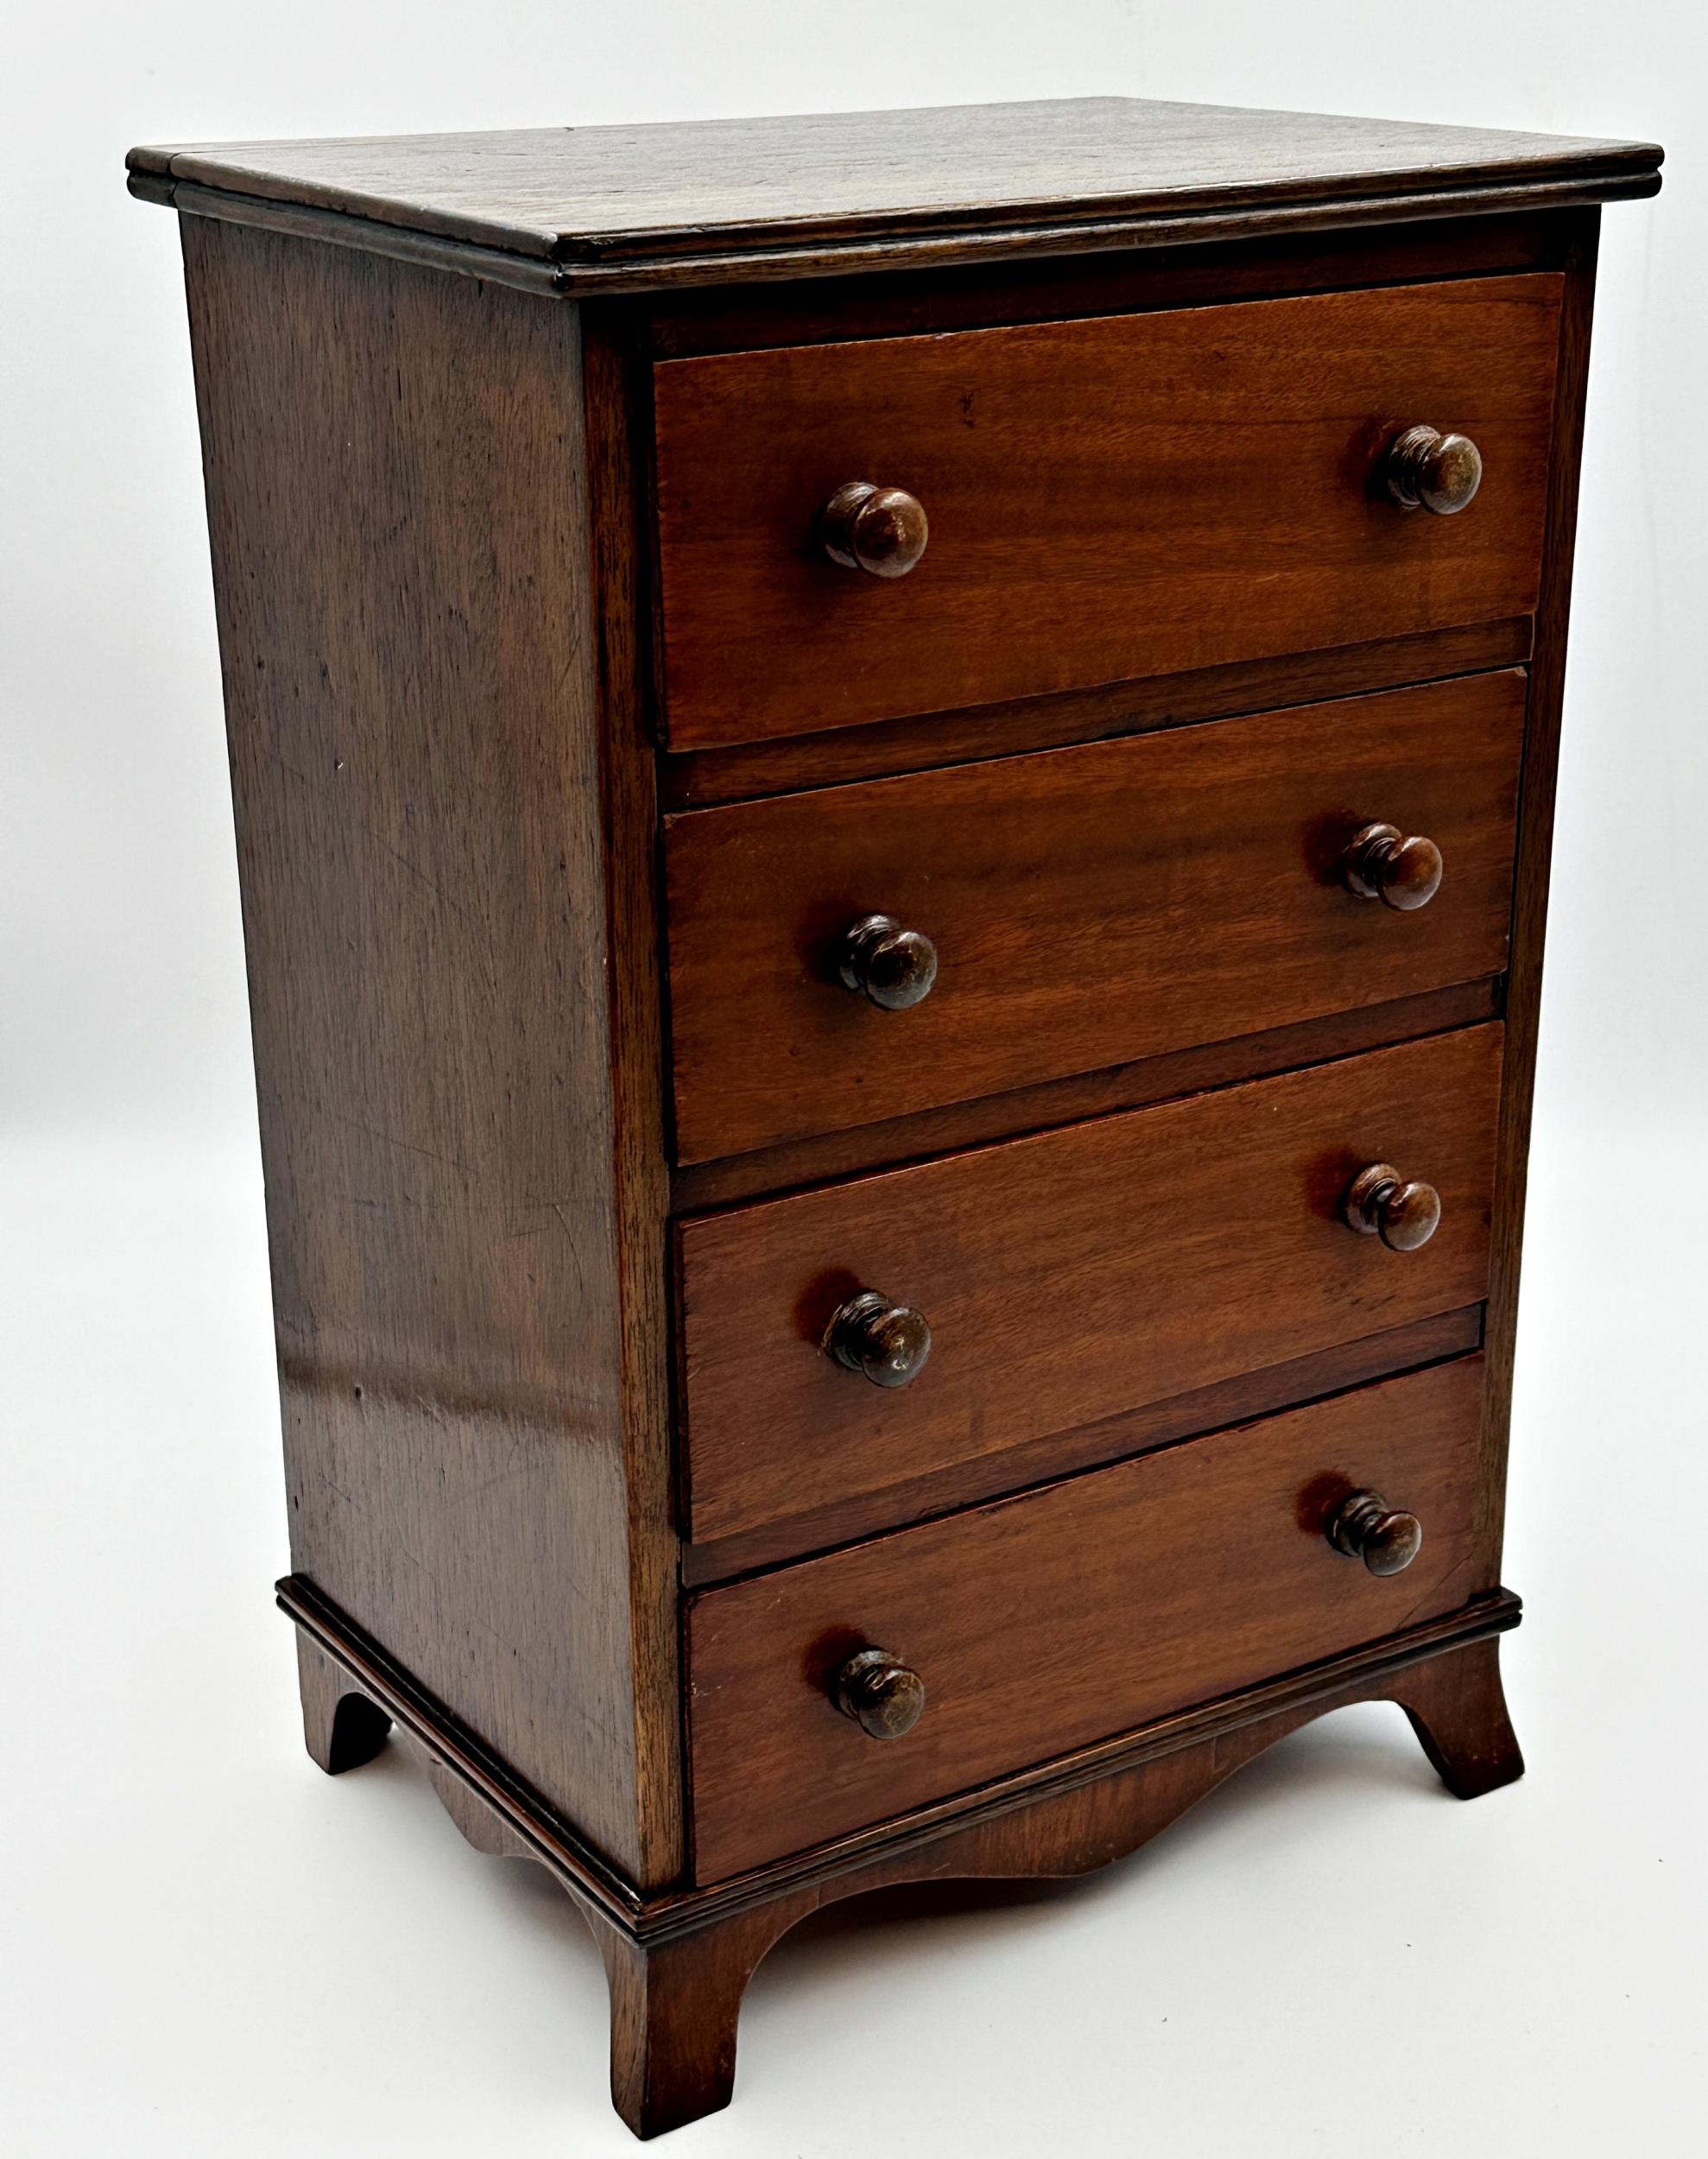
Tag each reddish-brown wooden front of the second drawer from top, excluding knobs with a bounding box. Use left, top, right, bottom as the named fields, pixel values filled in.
left=665, top=672, right=1524, bottom=1162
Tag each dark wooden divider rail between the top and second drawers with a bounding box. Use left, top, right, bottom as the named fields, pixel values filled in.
left=661, top=616, right=1531, bottom=810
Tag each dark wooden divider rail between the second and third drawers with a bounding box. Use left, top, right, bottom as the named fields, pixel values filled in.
left=669, top=976, right=1505, bottom=1216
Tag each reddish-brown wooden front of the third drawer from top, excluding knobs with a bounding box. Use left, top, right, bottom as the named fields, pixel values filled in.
left=678, top=1026, right=1501, bottom=1542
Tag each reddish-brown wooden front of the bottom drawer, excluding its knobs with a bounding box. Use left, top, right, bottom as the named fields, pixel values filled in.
left=689, top=1358, right=1496, bottom=1881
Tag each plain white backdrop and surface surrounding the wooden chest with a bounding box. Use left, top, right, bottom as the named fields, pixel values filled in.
left=0, top=0, right=1708, bottom=2159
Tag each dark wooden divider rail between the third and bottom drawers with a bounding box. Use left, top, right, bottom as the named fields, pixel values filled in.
left=682, top=1304, right=1483, bottom=1589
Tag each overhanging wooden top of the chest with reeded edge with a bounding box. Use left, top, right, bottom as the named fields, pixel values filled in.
left=128, top=98, right=1661, bottom=292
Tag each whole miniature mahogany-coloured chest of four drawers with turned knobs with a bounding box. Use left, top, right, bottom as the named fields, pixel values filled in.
left=132, top=99, right=1661, bottom=2136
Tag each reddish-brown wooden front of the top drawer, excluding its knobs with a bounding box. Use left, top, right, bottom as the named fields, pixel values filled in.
left=655, top=275, right=1563, bottom=750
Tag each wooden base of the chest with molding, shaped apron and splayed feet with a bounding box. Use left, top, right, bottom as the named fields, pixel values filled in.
left=279, top=1576, right=1524, bottom=2137
